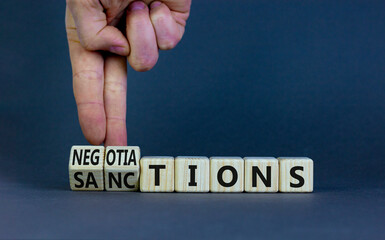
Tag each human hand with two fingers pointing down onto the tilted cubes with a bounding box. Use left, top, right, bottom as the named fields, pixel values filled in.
left=66, top=0, right=191, bottom=145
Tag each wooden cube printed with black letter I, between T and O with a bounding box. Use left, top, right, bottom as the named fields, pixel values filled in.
left=175, top=157, right=210, bottom=192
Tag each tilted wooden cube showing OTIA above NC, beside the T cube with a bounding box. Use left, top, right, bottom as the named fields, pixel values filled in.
left=104, top=146, right=140, bottom=191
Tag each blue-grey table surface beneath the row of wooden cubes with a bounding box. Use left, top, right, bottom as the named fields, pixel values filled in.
left=0, top=184, right=385, bottom=239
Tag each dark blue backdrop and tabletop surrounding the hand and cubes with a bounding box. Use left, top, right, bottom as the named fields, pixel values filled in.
left=0, top=0, right=385, bottom=239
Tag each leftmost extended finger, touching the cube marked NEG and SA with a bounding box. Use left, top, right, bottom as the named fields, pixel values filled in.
left=66, top=8, right=106, bottom=145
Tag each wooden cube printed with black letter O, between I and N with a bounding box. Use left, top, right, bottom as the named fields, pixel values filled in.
left=210, top=157, right=244, bottom=192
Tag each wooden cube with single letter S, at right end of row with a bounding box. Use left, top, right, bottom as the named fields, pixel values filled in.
left=278, top=157, right=313, bottom=192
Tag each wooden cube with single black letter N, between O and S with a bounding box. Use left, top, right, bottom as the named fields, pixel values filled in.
left=243, top=157, right=279, bottom=192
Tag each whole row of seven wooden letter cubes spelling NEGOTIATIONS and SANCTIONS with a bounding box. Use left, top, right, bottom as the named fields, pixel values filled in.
left=69, top=146, right=313, bottom=192
